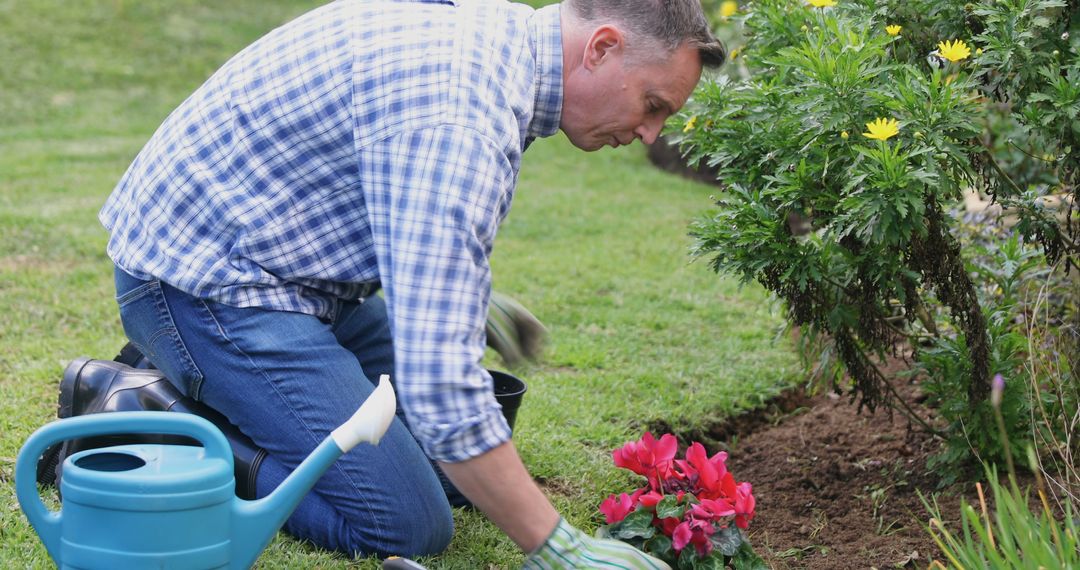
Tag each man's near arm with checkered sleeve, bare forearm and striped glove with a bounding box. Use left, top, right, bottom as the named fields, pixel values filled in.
left=360, top=125, right=666, bottom=569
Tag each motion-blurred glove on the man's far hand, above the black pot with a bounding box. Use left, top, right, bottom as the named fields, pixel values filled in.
left=485, top=291, right=548, bottom=367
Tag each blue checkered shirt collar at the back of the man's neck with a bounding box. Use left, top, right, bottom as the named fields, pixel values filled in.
left=527, top=4, right=563, bottom=139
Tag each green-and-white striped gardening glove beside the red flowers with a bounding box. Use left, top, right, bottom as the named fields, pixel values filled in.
left=522, top=518, right=671, bottom=570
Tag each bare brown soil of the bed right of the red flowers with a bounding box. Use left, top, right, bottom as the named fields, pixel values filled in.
left=716, top=373, right=956, bottom=569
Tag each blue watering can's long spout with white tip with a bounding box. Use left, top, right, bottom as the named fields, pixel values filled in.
left=232, top=375, right=397, bottom=568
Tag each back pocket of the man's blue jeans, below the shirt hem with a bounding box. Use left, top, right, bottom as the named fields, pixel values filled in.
left=117, top=275, right=203, bottom=399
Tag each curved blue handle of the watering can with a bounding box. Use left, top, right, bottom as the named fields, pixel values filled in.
left=15, top=411, right=232, bottom=560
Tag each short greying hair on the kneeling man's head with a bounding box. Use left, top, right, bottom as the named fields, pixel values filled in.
left=563, top=0, right=727, bottom=67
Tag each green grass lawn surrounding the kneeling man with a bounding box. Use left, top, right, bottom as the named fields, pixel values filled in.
left=0, top=0, right=797, bottom=568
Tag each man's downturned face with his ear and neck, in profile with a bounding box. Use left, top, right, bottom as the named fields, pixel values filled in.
left=559, top=28, right=701, bottom=150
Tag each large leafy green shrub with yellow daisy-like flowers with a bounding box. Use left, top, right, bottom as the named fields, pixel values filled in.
left=673, top=0, right=1080, bottom=472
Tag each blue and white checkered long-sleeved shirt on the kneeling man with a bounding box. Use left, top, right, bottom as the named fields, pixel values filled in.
left=99, top=0, right=563, bottom=462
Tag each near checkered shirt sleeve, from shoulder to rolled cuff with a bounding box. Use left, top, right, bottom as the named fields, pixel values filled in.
left=360, top=125, right=515, bottom=462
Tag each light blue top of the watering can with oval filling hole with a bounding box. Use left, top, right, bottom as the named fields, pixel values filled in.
left=60, top=444, right=234, bottom=501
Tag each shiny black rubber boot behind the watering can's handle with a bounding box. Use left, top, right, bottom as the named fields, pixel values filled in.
left=38, top=353, right=267, bottom=499
